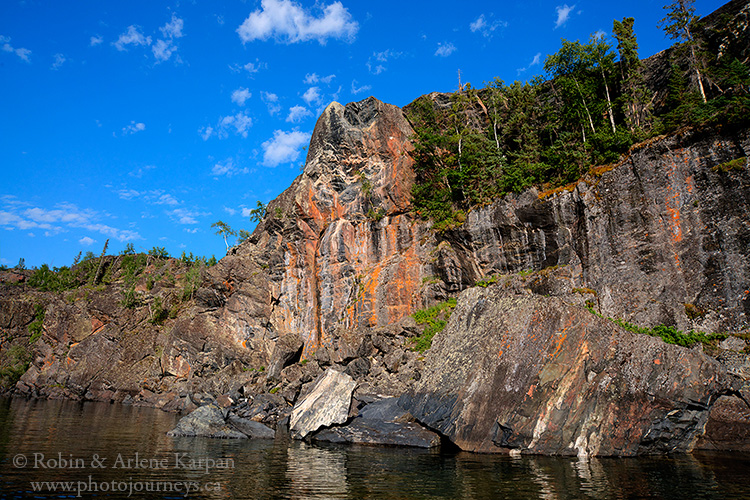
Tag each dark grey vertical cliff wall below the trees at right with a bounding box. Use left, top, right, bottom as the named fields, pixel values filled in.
left=428, top=132, right=750, bottom=331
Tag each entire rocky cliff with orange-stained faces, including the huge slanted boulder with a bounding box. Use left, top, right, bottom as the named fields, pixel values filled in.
left=0, top=0, right=750, bottom=455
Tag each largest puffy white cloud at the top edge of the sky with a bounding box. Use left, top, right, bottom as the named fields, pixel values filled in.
left=237, top=0, right=359, bottom=44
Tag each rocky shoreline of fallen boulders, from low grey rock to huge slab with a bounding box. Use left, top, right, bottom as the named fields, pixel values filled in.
left=170, top=271, right=750, bottom=457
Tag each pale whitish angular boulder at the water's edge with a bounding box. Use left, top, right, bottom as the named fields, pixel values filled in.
left=289, top=368, right=357, bottom=439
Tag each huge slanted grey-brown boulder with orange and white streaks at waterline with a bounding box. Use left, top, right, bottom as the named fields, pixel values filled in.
left=399, top=286, right=733, bottom=456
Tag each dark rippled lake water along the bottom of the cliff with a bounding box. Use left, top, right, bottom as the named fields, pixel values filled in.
left=0, top=399, right=750, bottom=500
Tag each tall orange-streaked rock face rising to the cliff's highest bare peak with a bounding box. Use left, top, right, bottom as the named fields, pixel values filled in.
left=219, top=98, right=425, bottom=355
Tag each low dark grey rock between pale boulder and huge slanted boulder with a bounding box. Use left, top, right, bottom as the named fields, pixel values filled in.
left=312, top=398, right=440, bottom=448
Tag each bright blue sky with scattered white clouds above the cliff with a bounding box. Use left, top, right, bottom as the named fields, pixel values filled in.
left=0, top=0, right=723, bottom=267
